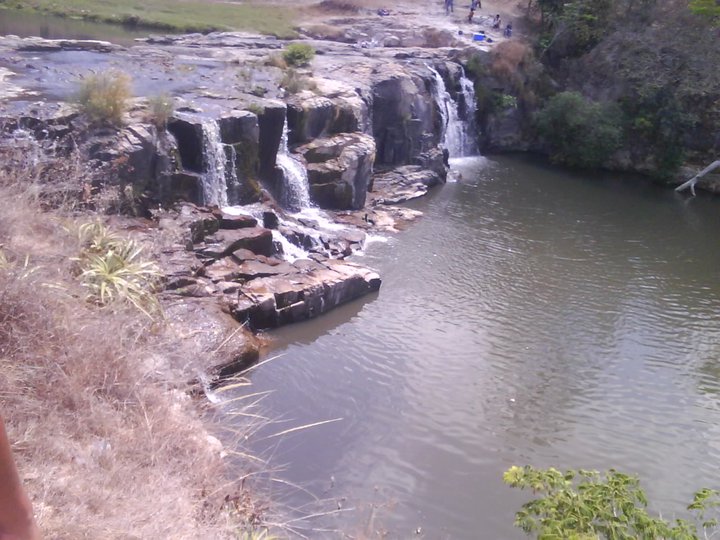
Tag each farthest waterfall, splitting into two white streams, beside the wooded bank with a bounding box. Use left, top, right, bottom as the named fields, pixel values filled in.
left=427, top=66, right=476, bottom=158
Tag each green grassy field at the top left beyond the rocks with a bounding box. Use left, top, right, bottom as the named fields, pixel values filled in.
left=0, top=0, right=297, bottom=37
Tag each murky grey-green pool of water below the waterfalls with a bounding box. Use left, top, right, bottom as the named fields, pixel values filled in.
left=239, top=157, right=720, bottom=539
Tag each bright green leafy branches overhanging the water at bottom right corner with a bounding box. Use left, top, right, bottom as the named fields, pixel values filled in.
left=503, top=466, right=720, bottom=540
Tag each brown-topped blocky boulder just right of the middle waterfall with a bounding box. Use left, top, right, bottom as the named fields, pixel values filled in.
left=297, top=133, right=375, bottom=210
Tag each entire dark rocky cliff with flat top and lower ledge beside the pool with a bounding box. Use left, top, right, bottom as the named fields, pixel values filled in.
left=0, top=34, right=478, bottom=358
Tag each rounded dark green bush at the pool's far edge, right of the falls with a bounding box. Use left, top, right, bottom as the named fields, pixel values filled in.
left=536, top=92, right=622, bottom=168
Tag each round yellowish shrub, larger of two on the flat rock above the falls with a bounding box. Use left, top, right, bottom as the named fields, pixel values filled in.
left=77, top=69, right=131, bottom=126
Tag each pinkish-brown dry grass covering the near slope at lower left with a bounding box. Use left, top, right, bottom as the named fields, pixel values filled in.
left=0, top=137, right=266, bottom=539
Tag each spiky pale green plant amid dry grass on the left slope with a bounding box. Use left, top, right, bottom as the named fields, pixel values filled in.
left=75, top=223, right=161, bottom=318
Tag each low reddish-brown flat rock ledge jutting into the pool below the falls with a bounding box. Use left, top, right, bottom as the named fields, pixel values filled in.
left=158, top=204, right=381, bottom=336
